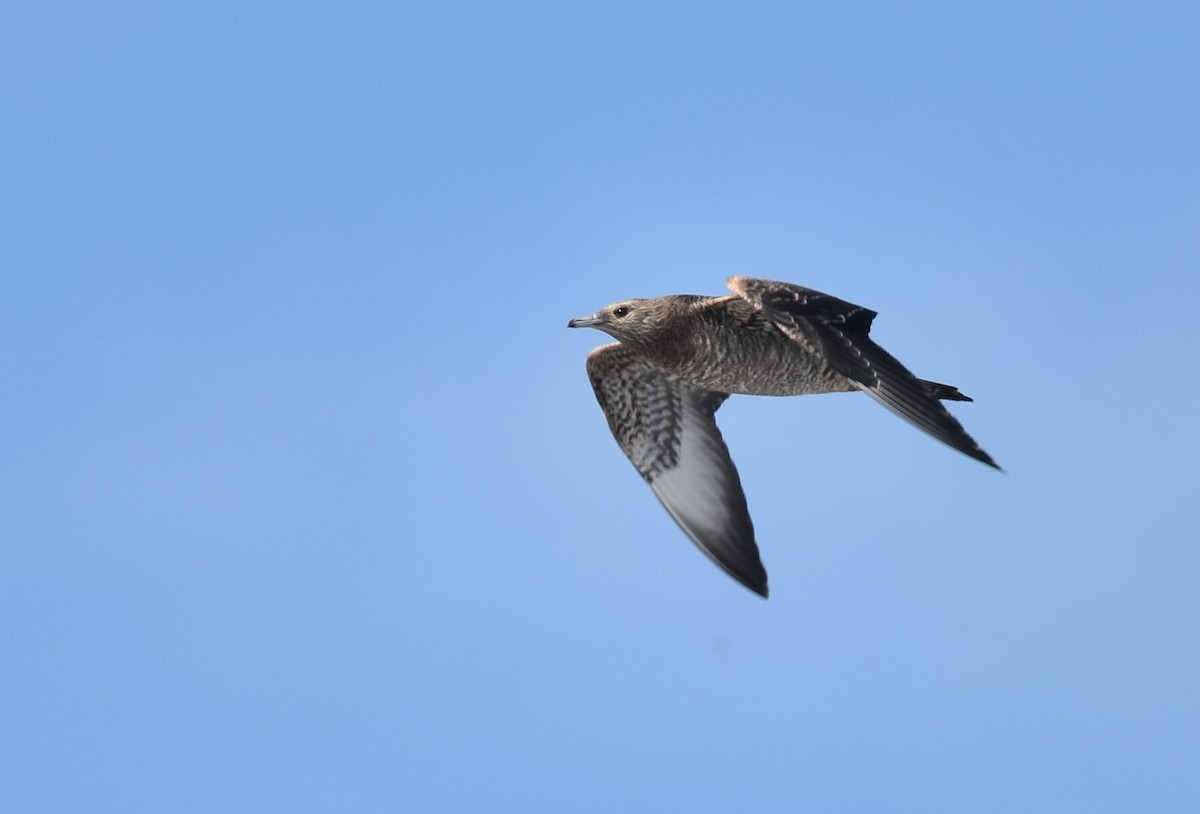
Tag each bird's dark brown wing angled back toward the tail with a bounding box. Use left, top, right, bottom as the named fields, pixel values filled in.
left=728, top=277, right=1000, bottom=469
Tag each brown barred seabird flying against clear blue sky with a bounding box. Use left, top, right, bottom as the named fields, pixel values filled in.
left=566, top=276, right=1000, bottom=597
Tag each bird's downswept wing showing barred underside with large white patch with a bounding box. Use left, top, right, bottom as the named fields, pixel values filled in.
left=588, top=343, right=767, bottom=597
